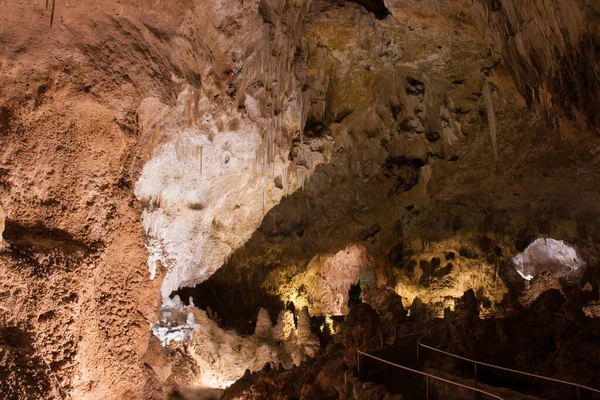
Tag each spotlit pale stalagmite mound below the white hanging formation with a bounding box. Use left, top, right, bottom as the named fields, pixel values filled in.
left=147, top=306, right=319, bottom=394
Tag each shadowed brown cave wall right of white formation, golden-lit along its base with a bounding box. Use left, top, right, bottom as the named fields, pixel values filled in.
left=186, top=1, right=600, bottom=330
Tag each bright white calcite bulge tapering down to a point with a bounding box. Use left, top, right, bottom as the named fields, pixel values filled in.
left=135, top=89, right=308, bottom=297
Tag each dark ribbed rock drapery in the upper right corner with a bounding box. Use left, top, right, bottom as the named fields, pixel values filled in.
left=478, top=0, right=600, bottom=134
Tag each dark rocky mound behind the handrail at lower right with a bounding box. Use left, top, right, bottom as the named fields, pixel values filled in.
left=423, top=283, right=600, bottom=399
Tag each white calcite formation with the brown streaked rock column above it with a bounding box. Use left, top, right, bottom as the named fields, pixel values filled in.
left=135, top=1, right=333, bottom=297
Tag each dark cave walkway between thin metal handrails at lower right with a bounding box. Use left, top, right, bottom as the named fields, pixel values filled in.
left=357, top=320, right=600, bottom=400
